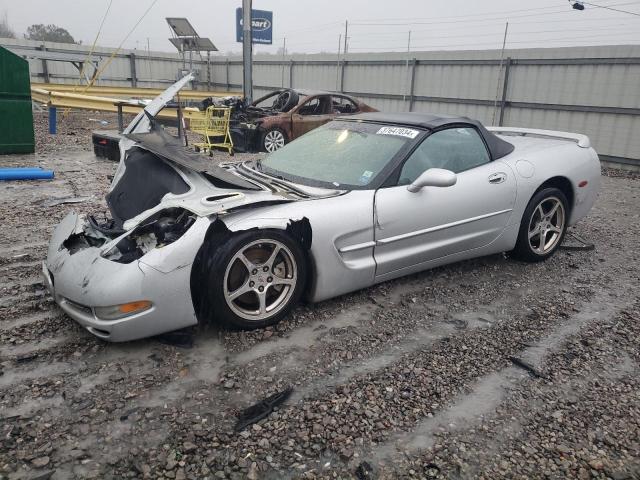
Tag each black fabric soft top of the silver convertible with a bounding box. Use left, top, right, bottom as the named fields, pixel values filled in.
left=340, top=112, right=515, bottom=160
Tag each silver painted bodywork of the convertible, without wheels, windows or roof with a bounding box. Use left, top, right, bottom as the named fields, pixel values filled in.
left=43, top=77, right=600, bottom=341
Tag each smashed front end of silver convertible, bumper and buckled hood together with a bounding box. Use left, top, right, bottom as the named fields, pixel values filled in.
left=43, top=76, right=248, bottom=342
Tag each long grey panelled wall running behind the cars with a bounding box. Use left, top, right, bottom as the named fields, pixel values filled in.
left=0, top=39, right=640, bottom=168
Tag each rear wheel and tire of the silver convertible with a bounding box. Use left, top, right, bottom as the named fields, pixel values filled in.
left=512, top=188, right=569, bottom=262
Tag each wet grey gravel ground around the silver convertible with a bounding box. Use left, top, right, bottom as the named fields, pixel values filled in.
left=0, top=114, right=640, bottom=479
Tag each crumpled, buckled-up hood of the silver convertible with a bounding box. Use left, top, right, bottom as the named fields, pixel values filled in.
left=106, top=75, right=344, bottom=230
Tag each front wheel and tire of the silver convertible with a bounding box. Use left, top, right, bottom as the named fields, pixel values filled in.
left=206, top=230, right=307, bottom=329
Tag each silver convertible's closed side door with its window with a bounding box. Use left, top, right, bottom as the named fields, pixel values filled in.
left=374, top=127, right=516, bottom=276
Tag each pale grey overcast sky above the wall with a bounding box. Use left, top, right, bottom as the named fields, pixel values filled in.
left=0, top=0, right=640, bottom=54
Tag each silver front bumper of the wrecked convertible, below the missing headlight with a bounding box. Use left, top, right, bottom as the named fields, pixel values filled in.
left=42, top=212, right=209, bottom=342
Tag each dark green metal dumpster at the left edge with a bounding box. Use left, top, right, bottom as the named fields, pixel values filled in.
left=0, top=47, right=35, bottom=154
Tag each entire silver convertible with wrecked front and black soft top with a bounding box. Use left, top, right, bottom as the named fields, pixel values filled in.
left=43, top=78, right=600, bottom=341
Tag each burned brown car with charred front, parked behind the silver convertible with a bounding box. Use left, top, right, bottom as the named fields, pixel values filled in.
left=202, top=88, right=376, bottom=152
